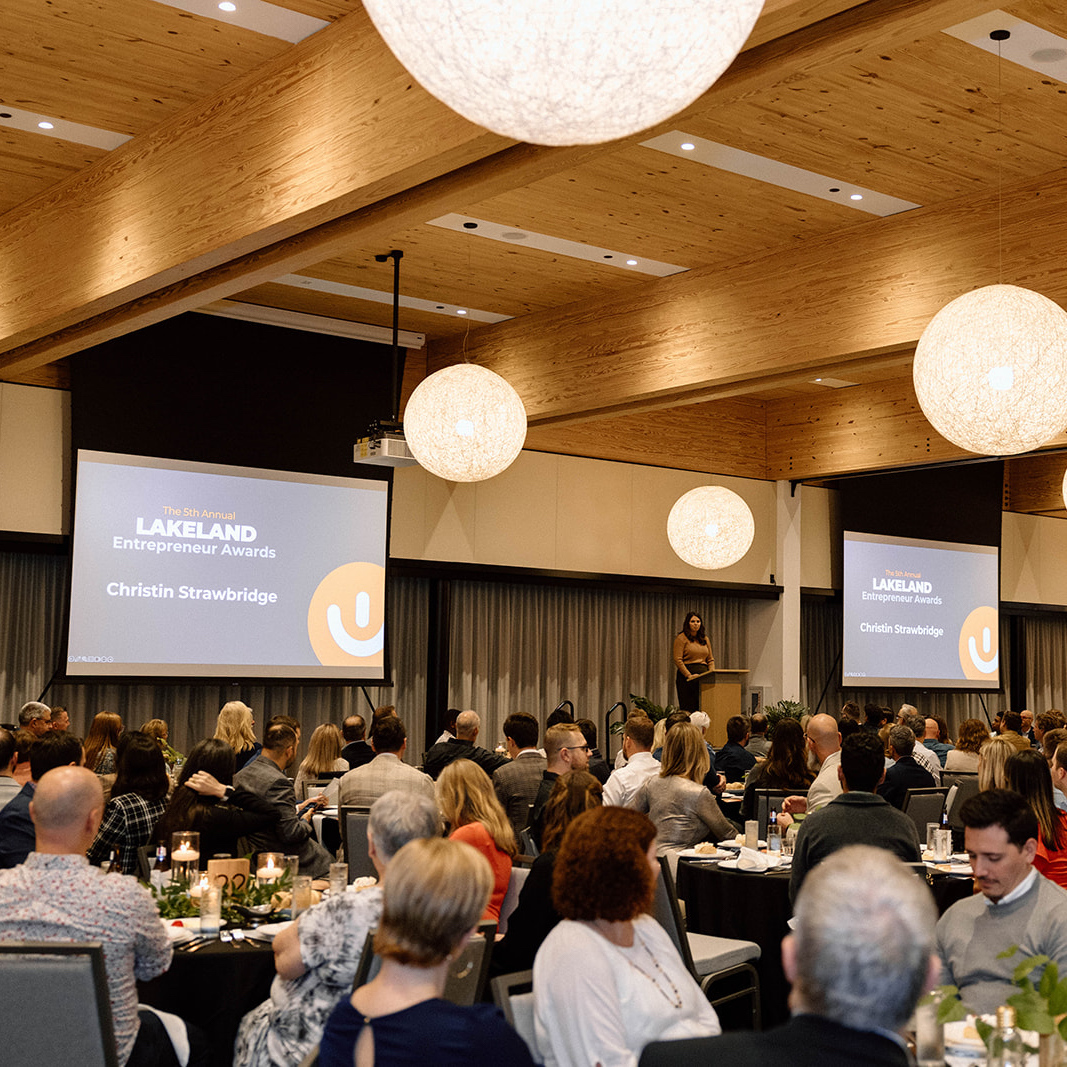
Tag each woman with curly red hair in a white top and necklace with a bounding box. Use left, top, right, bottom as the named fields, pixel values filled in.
left=534, top=808, right=719, bottom=1067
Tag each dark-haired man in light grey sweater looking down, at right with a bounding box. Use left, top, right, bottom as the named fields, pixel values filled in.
left=937, top=790, right=1067, bottom=1014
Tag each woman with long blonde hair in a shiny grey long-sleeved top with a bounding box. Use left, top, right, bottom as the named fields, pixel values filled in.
left=630, top=722, right=736, bottom=856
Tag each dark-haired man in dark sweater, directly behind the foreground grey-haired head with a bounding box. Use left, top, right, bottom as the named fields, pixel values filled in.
left=790, top=727, right=922, bottom=901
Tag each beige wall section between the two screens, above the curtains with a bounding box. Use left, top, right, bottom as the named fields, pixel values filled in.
left=391, top=451, right=775, bottom=584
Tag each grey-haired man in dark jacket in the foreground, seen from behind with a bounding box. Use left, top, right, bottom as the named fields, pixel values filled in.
left=641, top=845, right=938, bottom=1067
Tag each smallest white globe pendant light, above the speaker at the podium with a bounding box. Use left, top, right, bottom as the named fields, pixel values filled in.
left=667, top=485, right=755, bottom=571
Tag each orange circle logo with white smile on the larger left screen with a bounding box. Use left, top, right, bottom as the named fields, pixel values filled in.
left=307, top=563, right=385, bottom=667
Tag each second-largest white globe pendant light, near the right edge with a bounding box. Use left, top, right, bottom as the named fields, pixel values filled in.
left=912, top=285, right=1067, bottom=456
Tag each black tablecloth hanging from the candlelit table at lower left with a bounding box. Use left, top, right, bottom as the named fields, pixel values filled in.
left=138, top=940, right=274, bottom=1067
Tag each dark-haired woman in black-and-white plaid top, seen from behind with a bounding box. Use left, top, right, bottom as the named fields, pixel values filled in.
left=87, top=732, right=168, bottom=874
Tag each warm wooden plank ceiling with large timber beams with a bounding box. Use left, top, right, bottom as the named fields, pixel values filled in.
left=0, top=0, right=1067, bottom=513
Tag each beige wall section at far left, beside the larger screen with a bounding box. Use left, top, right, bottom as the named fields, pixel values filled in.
left=0, top=382, right=70, bottom=534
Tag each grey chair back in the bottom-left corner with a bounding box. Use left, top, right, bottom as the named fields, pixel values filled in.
left=0, top=941, right=118, bottom=1067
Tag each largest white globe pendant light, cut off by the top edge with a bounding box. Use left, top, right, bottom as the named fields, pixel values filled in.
left=364, top=0, right=763, bottom=145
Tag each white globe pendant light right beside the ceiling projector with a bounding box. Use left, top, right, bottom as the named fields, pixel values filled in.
left=403, top=363, right=526, bottom=481
